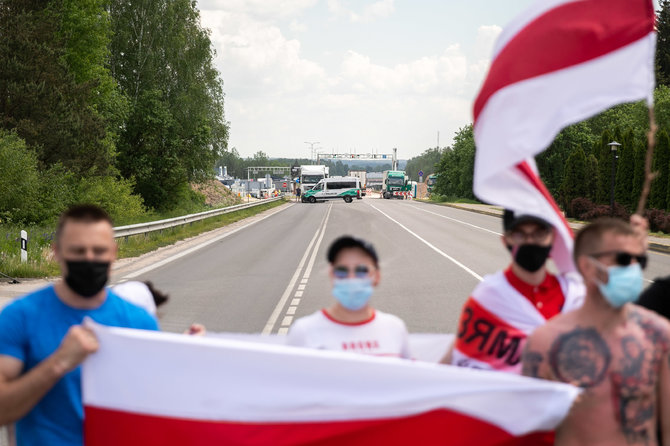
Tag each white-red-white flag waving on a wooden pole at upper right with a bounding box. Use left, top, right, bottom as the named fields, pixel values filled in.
left=474, top=0, right=656, bottom=272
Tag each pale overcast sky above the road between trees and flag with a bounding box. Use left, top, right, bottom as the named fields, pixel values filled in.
left=198, top=0, right=532, bottom=159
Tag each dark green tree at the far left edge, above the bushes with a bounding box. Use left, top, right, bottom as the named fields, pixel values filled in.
left=0, top=0, right=113, bottom=174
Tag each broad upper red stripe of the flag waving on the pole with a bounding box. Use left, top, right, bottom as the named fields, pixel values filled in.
left=474, top=0, right=655, bottom=122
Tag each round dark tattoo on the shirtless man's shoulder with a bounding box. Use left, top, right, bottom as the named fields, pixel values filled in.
left=549, top=328, right=612, bottom=388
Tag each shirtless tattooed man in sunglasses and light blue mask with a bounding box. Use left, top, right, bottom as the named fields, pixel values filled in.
left=523, top=219, right=670, bottom=446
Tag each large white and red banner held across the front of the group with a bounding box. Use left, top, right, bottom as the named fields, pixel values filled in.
left=82, top=324, right=580, bottom=446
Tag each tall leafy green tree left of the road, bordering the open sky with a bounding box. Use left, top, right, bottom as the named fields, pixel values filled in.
left=109, top=0, right=228, bottom=208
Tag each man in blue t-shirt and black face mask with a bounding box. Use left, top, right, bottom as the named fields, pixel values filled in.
left=0, top=205, right=158, bottom=446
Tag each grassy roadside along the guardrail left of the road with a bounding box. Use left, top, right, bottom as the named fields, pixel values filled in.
left=0, top=200, right=285, bottom=279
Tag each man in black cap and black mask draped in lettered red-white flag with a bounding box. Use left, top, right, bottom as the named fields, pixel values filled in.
left=443, top=210, right=584, bottom=373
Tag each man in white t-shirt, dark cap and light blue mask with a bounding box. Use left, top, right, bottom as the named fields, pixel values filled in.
left=287, top=236, right=410, bottom=358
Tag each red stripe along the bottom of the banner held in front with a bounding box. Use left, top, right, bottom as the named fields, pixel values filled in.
left=84, top=406, right=553, bottom=446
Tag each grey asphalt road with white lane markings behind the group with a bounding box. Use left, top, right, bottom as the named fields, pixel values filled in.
left=124, top=197, right=670, bottom=333
